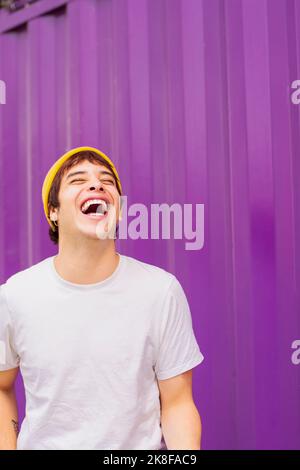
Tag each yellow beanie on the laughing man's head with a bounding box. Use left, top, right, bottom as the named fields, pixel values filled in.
left=42, top=147, right=122, bottom=231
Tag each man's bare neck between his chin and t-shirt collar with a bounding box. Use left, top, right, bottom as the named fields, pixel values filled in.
left=54, top=239, right=119, bottom=284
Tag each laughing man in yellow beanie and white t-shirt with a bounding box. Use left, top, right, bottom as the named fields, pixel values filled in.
left=0, top=147, right=203, bottom=450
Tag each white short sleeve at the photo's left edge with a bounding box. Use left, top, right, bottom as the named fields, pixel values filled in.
left=0, top=286, right=20, bottom=371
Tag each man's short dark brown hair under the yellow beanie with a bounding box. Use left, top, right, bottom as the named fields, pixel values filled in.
left=48, top=151, right=121, bottom=245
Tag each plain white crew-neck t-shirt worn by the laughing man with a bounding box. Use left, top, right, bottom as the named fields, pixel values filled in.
left=0, top=254, right=203, bottom=450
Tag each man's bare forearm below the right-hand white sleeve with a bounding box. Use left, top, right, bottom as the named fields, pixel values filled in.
left=158, top=370, right=202, bottom=450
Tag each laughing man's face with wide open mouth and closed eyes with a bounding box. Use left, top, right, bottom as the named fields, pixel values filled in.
left=51, top=161, right=120, bottom=239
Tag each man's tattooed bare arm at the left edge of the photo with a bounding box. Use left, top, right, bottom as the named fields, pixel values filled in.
left=0, top=367, right=19, bottom=450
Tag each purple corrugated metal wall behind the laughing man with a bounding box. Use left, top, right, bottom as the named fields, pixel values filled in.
left=0, top=0, right=300, bottom=449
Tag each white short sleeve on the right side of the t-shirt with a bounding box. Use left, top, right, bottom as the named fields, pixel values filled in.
left=154, top=277, right=204, bottom=380
